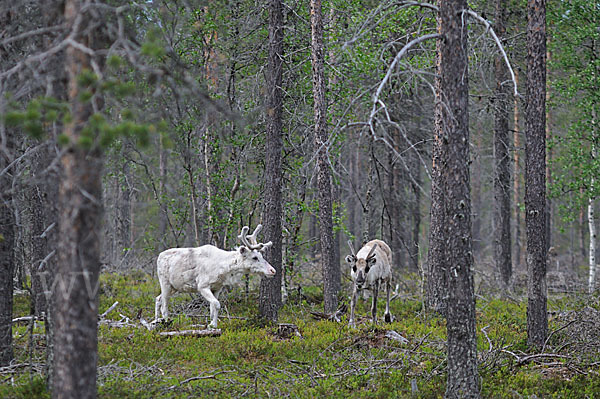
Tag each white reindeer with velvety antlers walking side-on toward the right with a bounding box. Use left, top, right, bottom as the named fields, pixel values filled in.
left=154, top=224, right=275, bottom=328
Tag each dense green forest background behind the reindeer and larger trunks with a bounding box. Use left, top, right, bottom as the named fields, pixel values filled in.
left=0, top=0, right=600, bottom=398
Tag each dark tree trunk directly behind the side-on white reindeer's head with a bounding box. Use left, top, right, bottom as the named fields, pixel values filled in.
left=258, top=0, right=283, bottom=321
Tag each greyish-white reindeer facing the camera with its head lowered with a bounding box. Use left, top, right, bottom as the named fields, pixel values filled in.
left=346, top=240, right=392, bottom=327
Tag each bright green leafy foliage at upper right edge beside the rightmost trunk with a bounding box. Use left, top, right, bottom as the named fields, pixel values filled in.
left=548, top=0, right=600, bottom=219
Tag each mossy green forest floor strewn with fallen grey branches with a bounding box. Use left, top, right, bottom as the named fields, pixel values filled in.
left=0, top=272, right=600, bottom=398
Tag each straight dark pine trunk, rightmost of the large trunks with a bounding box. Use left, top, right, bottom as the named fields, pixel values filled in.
left=525, top=0, right=548, bottom=348
